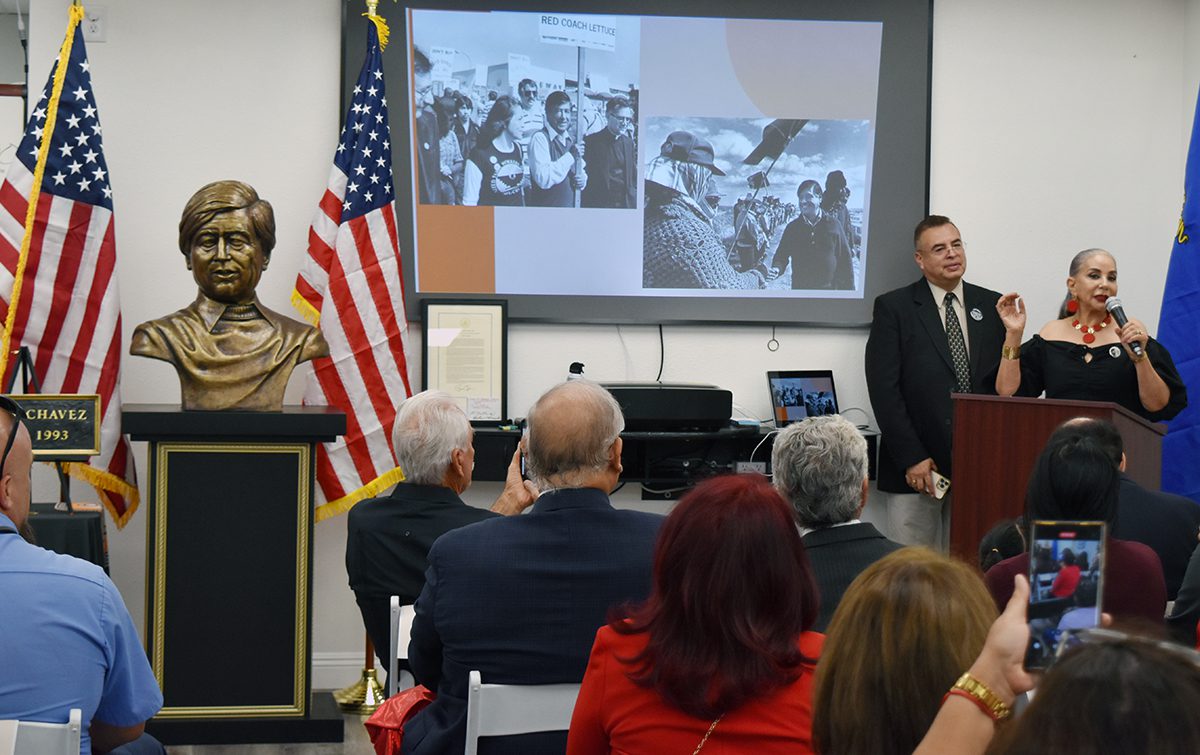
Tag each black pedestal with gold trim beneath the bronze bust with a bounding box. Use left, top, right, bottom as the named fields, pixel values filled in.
left=122, top=405, right=346, bottom=744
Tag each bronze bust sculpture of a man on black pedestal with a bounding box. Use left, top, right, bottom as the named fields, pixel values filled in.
left=130, top=181, right=329, bottom=412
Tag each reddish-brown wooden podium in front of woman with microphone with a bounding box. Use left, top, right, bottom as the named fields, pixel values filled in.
left=950, top=394, right=1166, bottom=563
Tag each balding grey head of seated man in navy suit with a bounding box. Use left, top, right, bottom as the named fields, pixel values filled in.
left=526, top=381, right=625, bottom=490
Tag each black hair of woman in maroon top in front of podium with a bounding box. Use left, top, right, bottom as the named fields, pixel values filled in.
left=1025, top=436, right=1121, bottom=528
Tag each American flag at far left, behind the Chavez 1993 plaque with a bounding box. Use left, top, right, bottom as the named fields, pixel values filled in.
left=0, top=6, right=138, bottom=527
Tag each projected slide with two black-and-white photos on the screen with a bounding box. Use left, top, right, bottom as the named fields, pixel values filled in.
left=408, top=10, right=882, bottom=299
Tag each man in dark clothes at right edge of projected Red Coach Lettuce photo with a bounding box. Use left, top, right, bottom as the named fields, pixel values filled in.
left=580, top=95, right=637, bottom=209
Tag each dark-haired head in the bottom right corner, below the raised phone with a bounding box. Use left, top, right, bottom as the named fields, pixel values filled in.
left=988, top=637, right=1200, bottom=755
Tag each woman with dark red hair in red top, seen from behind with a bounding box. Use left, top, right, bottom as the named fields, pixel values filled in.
left=566, top=475, right=824, bottom=755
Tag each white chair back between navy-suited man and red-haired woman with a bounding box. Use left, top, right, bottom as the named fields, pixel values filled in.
left=464, top=671, right=580, bottom=755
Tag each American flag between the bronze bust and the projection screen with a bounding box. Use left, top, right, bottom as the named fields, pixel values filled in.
left=292, top=17, right=412, bottom=521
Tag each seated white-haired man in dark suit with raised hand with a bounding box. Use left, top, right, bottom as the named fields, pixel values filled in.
left=346, top=391, right=536, bottom=667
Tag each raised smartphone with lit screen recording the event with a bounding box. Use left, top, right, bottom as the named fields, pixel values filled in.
left=1025, top=521, right=1106, bottom=670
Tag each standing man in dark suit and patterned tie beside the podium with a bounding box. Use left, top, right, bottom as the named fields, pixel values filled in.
left=866, top=215, right=1004, bottom=550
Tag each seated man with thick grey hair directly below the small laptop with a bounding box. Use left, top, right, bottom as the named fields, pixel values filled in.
left=770, top=414, right=904, bottom=631
